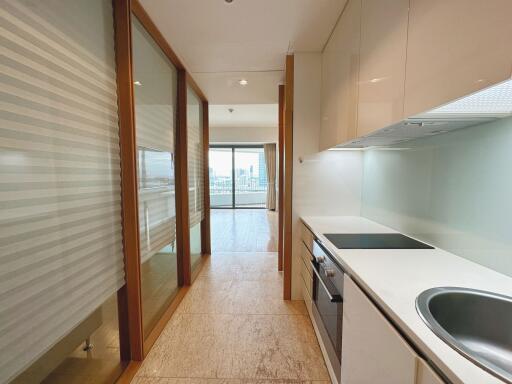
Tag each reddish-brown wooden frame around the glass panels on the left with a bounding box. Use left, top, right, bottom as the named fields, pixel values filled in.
left=113, top=0, right=211, bottom=383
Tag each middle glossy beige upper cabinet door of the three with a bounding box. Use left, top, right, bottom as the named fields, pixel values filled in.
left=356, top=0, right=409, bottom=137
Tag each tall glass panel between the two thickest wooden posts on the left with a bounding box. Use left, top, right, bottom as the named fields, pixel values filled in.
left=132, top=17, right=178, bottom=336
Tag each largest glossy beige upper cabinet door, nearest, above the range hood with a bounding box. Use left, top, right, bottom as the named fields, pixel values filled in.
left=404, top=0, right=512, bottom=117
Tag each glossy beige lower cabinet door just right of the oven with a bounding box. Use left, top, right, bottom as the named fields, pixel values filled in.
left=341, top=276, right=442, bottom=384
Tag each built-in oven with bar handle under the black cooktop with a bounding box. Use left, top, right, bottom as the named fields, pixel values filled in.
left=311, top=239, right=344, bottom=383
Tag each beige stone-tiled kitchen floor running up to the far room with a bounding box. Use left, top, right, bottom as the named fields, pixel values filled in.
left=132, top=211, right=330, bottom=384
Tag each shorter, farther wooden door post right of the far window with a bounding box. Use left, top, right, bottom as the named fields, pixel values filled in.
left=277, top=84, right=285, bottom=271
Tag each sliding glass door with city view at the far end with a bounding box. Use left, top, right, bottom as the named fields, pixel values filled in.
left=209, top=145, right=267, bottom=208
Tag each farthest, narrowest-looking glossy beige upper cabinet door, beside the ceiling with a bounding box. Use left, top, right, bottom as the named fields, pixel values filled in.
left=320, top=0, right=361, bottom=150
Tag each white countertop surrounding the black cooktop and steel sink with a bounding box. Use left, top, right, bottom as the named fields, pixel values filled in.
left=302, top=216, right=512, bottom=384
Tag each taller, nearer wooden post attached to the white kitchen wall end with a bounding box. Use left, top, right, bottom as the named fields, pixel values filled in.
left=283, top=55, right=294, bottom=300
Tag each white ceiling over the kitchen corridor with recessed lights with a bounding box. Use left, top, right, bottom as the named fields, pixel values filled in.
left=140, top=0, right=346, bottom=126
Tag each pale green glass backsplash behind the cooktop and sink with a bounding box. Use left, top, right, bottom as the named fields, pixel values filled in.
left=362, top=118, right=512, bottom=276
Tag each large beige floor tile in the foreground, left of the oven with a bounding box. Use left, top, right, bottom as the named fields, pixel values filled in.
left=138, top=314, right=328, bottom=380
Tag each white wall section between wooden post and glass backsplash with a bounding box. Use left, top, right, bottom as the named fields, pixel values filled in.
left=292, top=53, right=362, bottom=299
